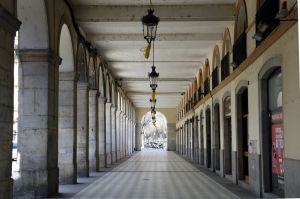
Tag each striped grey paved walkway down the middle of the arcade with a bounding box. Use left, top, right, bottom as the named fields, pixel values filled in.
left=73, top=149, right=255, bottom=199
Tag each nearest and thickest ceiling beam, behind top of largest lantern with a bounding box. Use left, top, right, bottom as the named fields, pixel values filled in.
left=74, top=4, right=234, bottom=22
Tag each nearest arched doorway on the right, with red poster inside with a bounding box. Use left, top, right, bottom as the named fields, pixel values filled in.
left=261, top=67, right=285, bottom=197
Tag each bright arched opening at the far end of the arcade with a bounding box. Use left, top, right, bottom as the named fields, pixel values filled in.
left=141, top=111, right=167, bottom=149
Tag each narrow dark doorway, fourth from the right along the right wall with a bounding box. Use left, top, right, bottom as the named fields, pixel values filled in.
left=214, top=104, right=221, bottom=171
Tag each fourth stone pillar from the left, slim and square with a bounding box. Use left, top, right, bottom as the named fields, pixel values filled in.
left=77, top=82, right=89, bottom=177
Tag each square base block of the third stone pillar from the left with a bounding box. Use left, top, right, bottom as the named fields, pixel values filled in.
left=58, top=163, right=77, bottom=184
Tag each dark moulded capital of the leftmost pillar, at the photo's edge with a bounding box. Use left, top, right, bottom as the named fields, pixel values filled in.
left=0, top=5, right=21, bottom=35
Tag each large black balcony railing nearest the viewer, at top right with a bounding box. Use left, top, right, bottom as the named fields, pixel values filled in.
left=255, top=0, right=279, bottom=46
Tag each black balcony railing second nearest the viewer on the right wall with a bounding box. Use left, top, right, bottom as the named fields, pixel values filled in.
left=233, top=32, right=247, bottom=67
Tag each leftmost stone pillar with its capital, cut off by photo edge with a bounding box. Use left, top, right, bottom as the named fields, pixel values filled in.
left=0, top=5, right=20, bottom=199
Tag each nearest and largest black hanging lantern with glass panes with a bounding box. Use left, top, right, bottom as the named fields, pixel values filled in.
left=142, top=0, right=159, bottom=43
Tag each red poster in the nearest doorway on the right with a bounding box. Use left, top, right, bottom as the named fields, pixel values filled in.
left=272, top=124, right=284, bottom=176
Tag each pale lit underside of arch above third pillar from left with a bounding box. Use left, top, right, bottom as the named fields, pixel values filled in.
left=58, top=24, right=75, bottom=72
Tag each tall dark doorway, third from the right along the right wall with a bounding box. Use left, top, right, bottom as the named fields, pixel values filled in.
left=223, top=97, right=232, bottom=175
